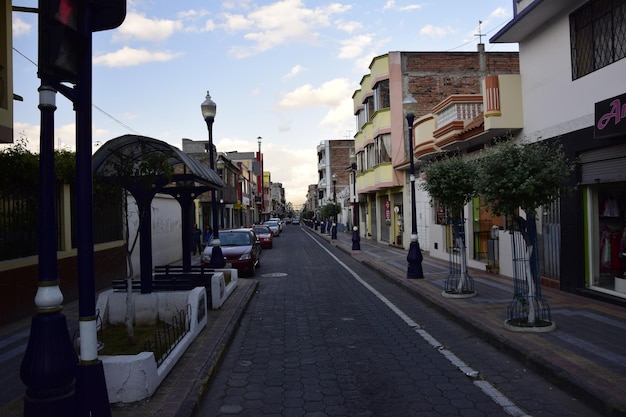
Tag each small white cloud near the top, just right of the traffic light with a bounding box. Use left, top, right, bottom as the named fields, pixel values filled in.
left=113, top=12, right=183, bottom=41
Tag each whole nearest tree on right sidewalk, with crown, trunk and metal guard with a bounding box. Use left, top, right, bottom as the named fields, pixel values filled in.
left=477, top=140, right=575, bottom=327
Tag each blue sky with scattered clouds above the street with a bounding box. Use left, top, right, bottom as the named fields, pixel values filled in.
left=12, top=0, right=517, bottom=208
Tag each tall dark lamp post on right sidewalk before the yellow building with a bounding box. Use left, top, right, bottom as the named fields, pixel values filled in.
left=402, top=96, right=424, bottom=278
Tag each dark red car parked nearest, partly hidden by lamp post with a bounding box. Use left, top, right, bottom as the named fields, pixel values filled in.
left=201, top=229, right=261, bottom=276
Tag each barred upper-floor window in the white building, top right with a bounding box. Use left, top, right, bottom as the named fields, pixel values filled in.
left=570, top=0, right=626, bottom=80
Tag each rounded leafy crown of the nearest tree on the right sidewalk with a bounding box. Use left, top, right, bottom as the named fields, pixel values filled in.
left=477, top=141, right=575, bottom=216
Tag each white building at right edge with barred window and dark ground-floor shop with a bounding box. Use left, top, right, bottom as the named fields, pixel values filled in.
left=490, top=0, right=626, bottom=305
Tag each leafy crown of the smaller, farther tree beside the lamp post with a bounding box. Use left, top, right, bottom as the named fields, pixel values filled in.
left=421, top=155, right=478, bottom=216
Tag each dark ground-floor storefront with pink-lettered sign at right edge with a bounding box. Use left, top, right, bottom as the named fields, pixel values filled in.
left=560, top=94, right=626, bottom=304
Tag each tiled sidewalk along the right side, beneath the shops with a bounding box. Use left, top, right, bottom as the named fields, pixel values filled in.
left=316, top=229, right=626, bottom=416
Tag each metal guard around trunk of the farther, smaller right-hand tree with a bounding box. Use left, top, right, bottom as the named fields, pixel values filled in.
left=441, top=218, right=476, bottom=298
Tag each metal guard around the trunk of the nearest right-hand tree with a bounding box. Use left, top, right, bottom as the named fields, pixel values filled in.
left=505, top=215, right=556, bottom=332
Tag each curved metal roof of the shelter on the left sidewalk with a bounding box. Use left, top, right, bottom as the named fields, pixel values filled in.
left=93, top=135, right=224, bottom=192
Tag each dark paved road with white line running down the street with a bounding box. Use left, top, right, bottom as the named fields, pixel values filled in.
left=196, top=226, right=599, bottom=417
